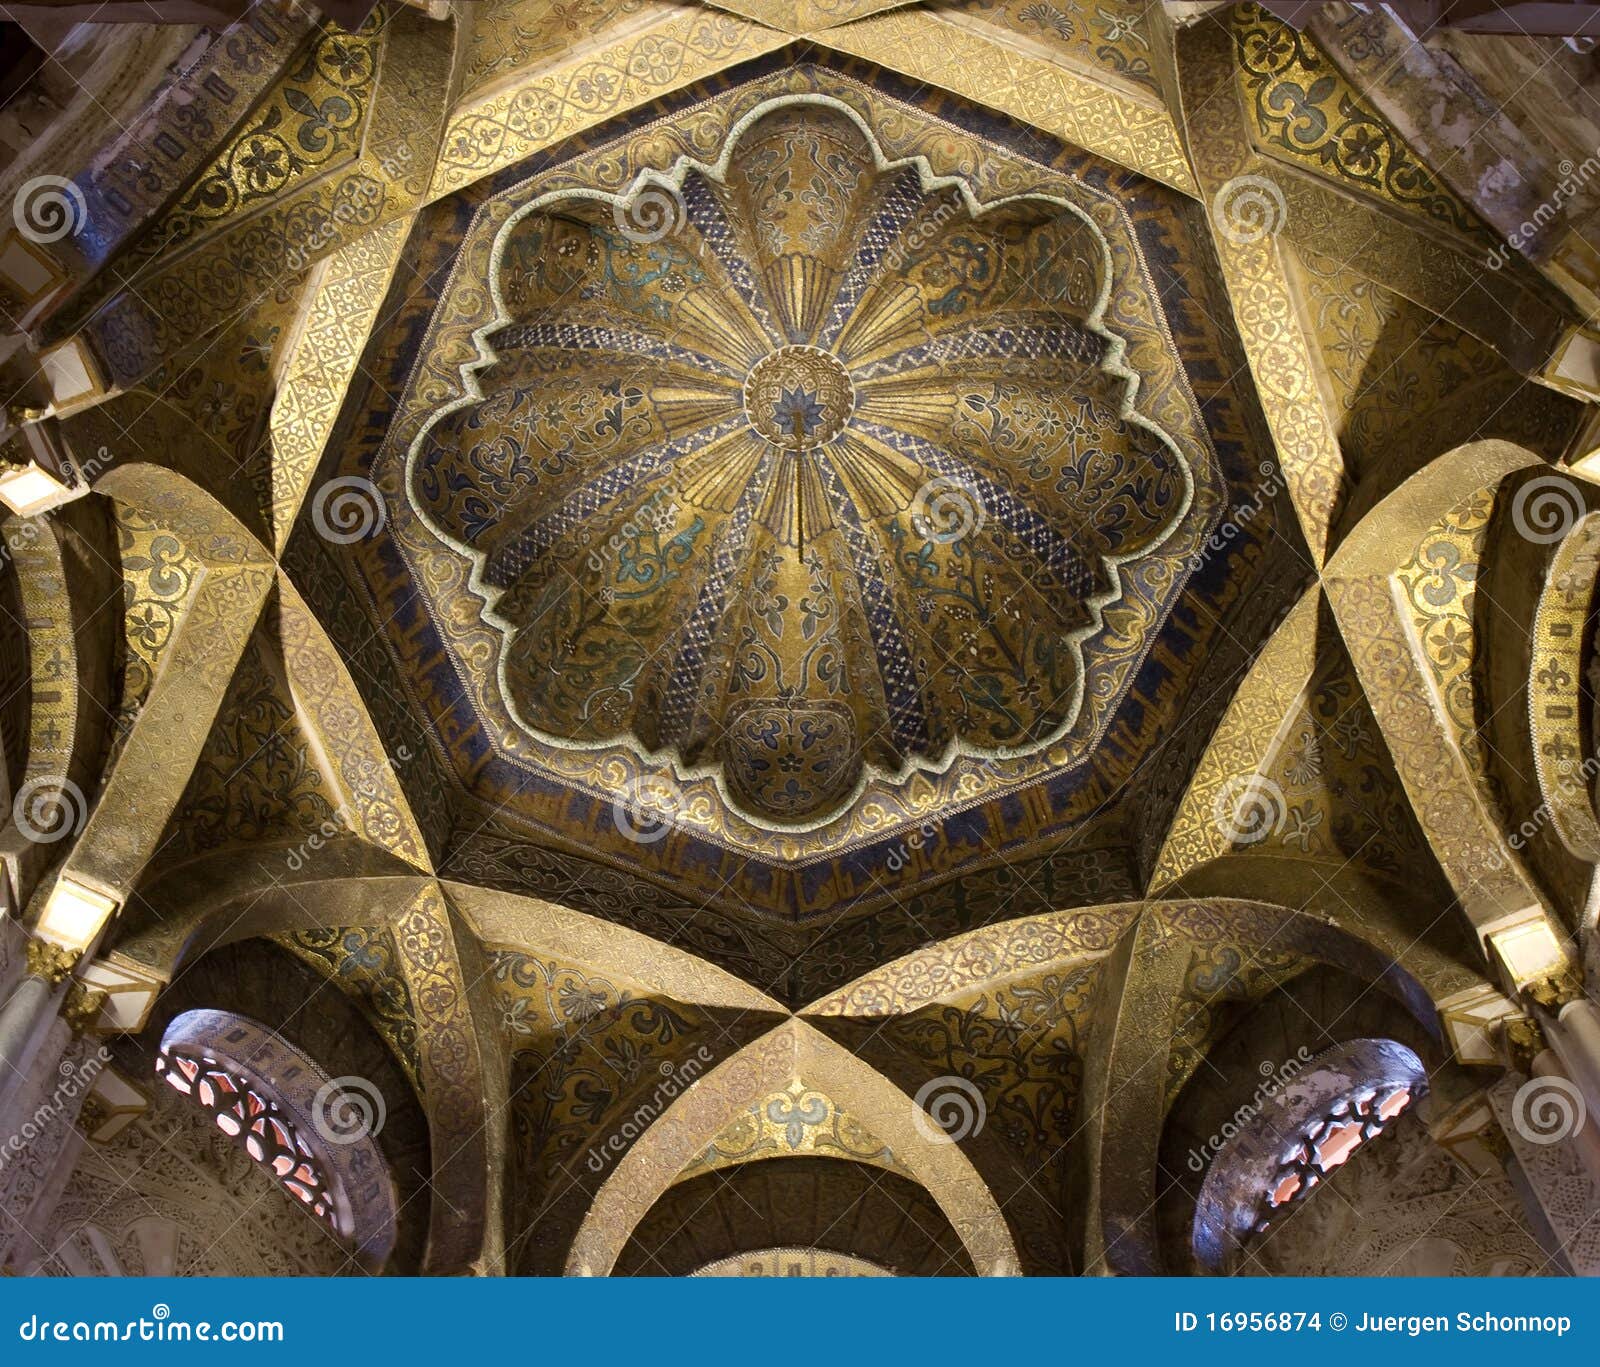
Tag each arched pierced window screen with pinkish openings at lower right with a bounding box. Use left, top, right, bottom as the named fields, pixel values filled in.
left=1194, top=1039, right=1427, bottom=1273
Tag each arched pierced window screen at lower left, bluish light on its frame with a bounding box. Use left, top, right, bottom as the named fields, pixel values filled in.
left=155, top=1010, right=398, bottom=1271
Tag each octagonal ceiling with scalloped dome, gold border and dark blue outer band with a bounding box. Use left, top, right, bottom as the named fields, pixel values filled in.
left=344, top=61, right=1248, bottom=896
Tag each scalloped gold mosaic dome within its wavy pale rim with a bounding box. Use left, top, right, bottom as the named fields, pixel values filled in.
left=408, top=102, right=1192, bottom=824
